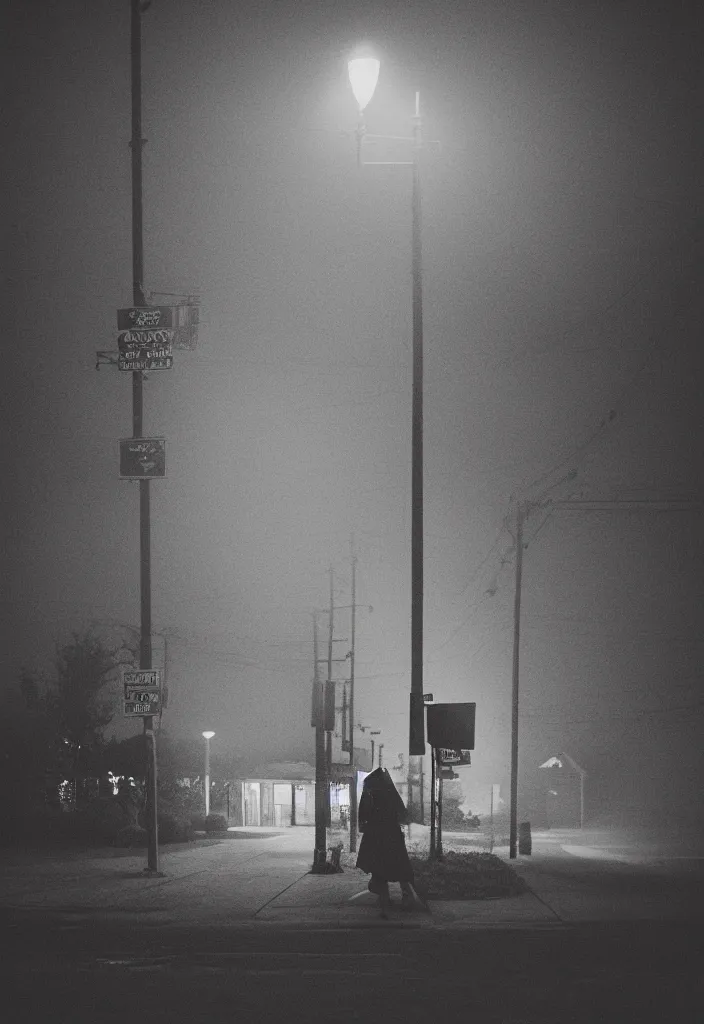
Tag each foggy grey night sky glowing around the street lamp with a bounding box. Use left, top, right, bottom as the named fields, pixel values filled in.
left=4, top=0, right=704, bottom=807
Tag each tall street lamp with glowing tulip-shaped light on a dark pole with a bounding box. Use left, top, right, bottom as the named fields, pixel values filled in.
left=347, top=56, right=426, bottom=756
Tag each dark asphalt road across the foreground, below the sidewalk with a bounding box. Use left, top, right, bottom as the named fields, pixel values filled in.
left=2, top=923, right=704, bottom=1024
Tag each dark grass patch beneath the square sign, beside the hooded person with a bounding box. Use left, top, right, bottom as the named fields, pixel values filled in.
left=410, top=852, right=527, bottom=899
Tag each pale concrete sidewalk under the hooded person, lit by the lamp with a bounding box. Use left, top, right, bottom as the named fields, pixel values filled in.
left=0, top=826, right=692, bottom=930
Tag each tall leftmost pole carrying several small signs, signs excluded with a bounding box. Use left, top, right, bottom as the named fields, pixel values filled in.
left=130, top=0, right=159, bottom=873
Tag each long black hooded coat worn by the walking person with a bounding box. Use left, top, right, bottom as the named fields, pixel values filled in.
left=357, top=768, right=413, bottom=883
